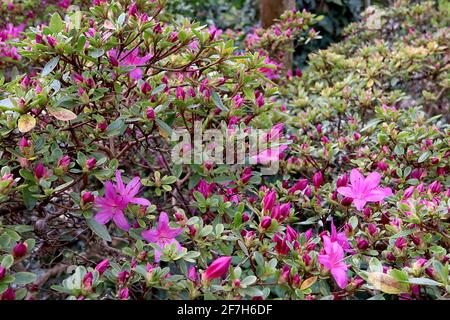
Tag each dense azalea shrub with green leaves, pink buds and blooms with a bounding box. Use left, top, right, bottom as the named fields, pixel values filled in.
left=0, top=0, right=450, bottom=300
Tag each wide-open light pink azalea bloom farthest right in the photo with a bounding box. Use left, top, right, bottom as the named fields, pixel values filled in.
left=337, top=169, right=392, bottom=211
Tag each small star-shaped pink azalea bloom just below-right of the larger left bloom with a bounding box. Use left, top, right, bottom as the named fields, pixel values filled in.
left=142, top=212, right=183, bottom=262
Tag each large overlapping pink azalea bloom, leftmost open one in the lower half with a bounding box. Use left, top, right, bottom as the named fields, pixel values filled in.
left=95, top=170, right=151, bottom=231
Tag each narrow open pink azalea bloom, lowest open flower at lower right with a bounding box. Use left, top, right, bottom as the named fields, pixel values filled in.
left=318, top=236, right=347, bottom=289
